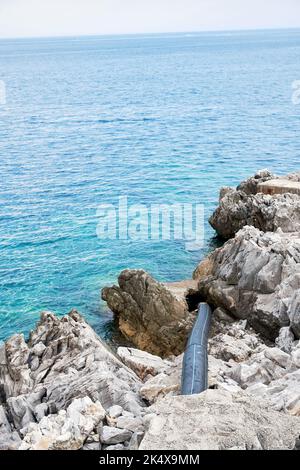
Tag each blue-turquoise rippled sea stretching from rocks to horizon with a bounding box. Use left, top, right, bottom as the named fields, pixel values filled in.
left=0, top=31, right=300, bottom=339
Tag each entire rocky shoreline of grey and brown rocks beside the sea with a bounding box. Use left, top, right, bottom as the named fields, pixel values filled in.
left=0, top=170, right=300, bottom=450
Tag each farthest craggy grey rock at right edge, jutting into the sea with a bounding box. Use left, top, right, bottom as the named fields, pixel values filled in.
left=210, top=170, right=300, bottom=239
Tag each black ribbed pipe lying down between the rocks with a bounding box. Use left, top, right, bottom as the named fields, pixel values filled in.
left=181, top=303, right=212, bottom=395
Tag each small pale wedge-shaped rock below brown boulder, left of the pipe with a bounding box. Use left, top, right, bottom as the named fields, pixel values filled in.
left=118, top=347, right=171, bottom=380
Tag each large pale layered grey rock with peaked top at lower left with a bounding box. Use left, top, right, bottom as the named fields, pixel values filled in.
left=0, top=311, right=144, bottom=448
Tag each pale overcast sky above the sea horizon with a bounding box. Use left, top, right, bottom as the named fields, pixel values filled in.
left=0, top=0, right=300, bottom=38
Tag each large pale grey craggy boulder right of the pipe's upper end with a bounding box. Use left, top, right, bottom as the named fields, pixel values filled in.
left=199, top=227, right=300, bottom=341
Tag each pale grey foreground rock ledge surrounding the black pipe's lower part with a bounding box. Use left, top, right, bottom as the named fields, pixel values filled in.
left=0, top=312, right=300, bottom=450
